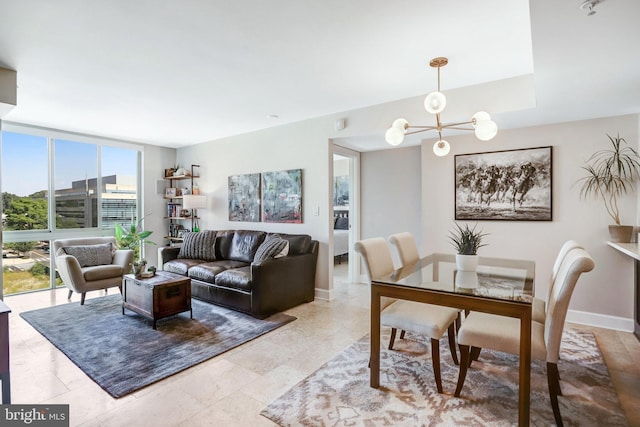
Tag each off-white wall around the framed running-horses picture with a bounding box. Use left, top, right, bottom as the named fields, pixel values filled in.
left=422, top=115, right=639, bottom=330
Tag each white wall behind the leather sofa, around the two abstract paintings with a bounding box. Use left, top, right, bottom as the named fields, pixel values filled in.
left=176, top=119, right=333, bottom=299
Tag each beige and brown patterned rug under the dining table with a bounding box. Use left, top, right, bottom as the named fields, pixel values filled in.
left=261, top=330, right=628, bottom=427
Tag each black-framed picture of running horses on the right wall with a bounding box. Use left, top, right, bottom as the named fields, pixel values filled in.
left=455, top=146, right=552, bottom=221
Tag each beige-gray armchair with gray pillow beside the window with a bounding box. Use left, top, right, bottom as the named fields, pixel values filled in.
left=53, top=237, right=133, bottom=305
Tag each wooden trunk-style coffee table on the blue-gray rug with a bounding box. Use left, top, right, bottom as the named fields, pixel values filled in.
left=122, top=271, right=193, bottom=329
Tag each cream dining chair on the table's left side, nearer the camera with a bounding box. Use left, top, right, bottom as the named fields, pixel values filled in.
left=355, top=237, right=458, bottom=393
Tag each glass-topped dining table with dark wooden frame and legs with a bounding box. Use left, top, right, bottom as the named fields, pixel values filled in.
left=370, top=253, right=535, bottom=426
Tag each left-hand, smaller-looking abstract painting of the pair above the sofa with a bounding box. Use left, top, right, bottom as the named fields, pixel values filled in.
left=229, top=173, right=260, bottom=222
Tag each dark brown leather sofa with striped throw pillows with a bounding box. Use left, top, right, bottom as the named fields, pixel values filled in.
left=158, top=230, right=318, bottom=318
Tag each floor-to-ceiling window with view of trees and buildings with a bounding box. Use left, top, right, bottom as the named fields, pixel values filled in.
left=0, top=123, right=141, bottom=296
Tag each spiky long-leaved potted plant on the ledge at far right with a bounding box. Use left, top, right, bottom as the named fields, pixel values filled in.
left=578, top=134, right=640, bottom=243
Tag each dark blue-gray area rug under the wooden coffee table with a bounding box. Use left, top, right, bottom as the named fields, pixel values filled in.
left=20, top=295, right=296, bottom=398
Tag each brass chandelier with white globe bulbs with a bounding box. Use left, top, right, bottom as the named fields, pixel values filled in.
left=384, top=57, right=498, bottom=156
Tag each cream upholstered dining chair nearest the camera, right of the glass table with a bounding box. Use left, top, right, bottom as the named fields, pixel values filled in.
left=454, top=248, right=595, bottom=426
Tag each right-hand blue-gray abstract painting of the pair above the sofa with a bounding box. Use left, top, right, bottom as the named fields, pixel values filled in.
left=262, top=169, right=302, bottom=224
